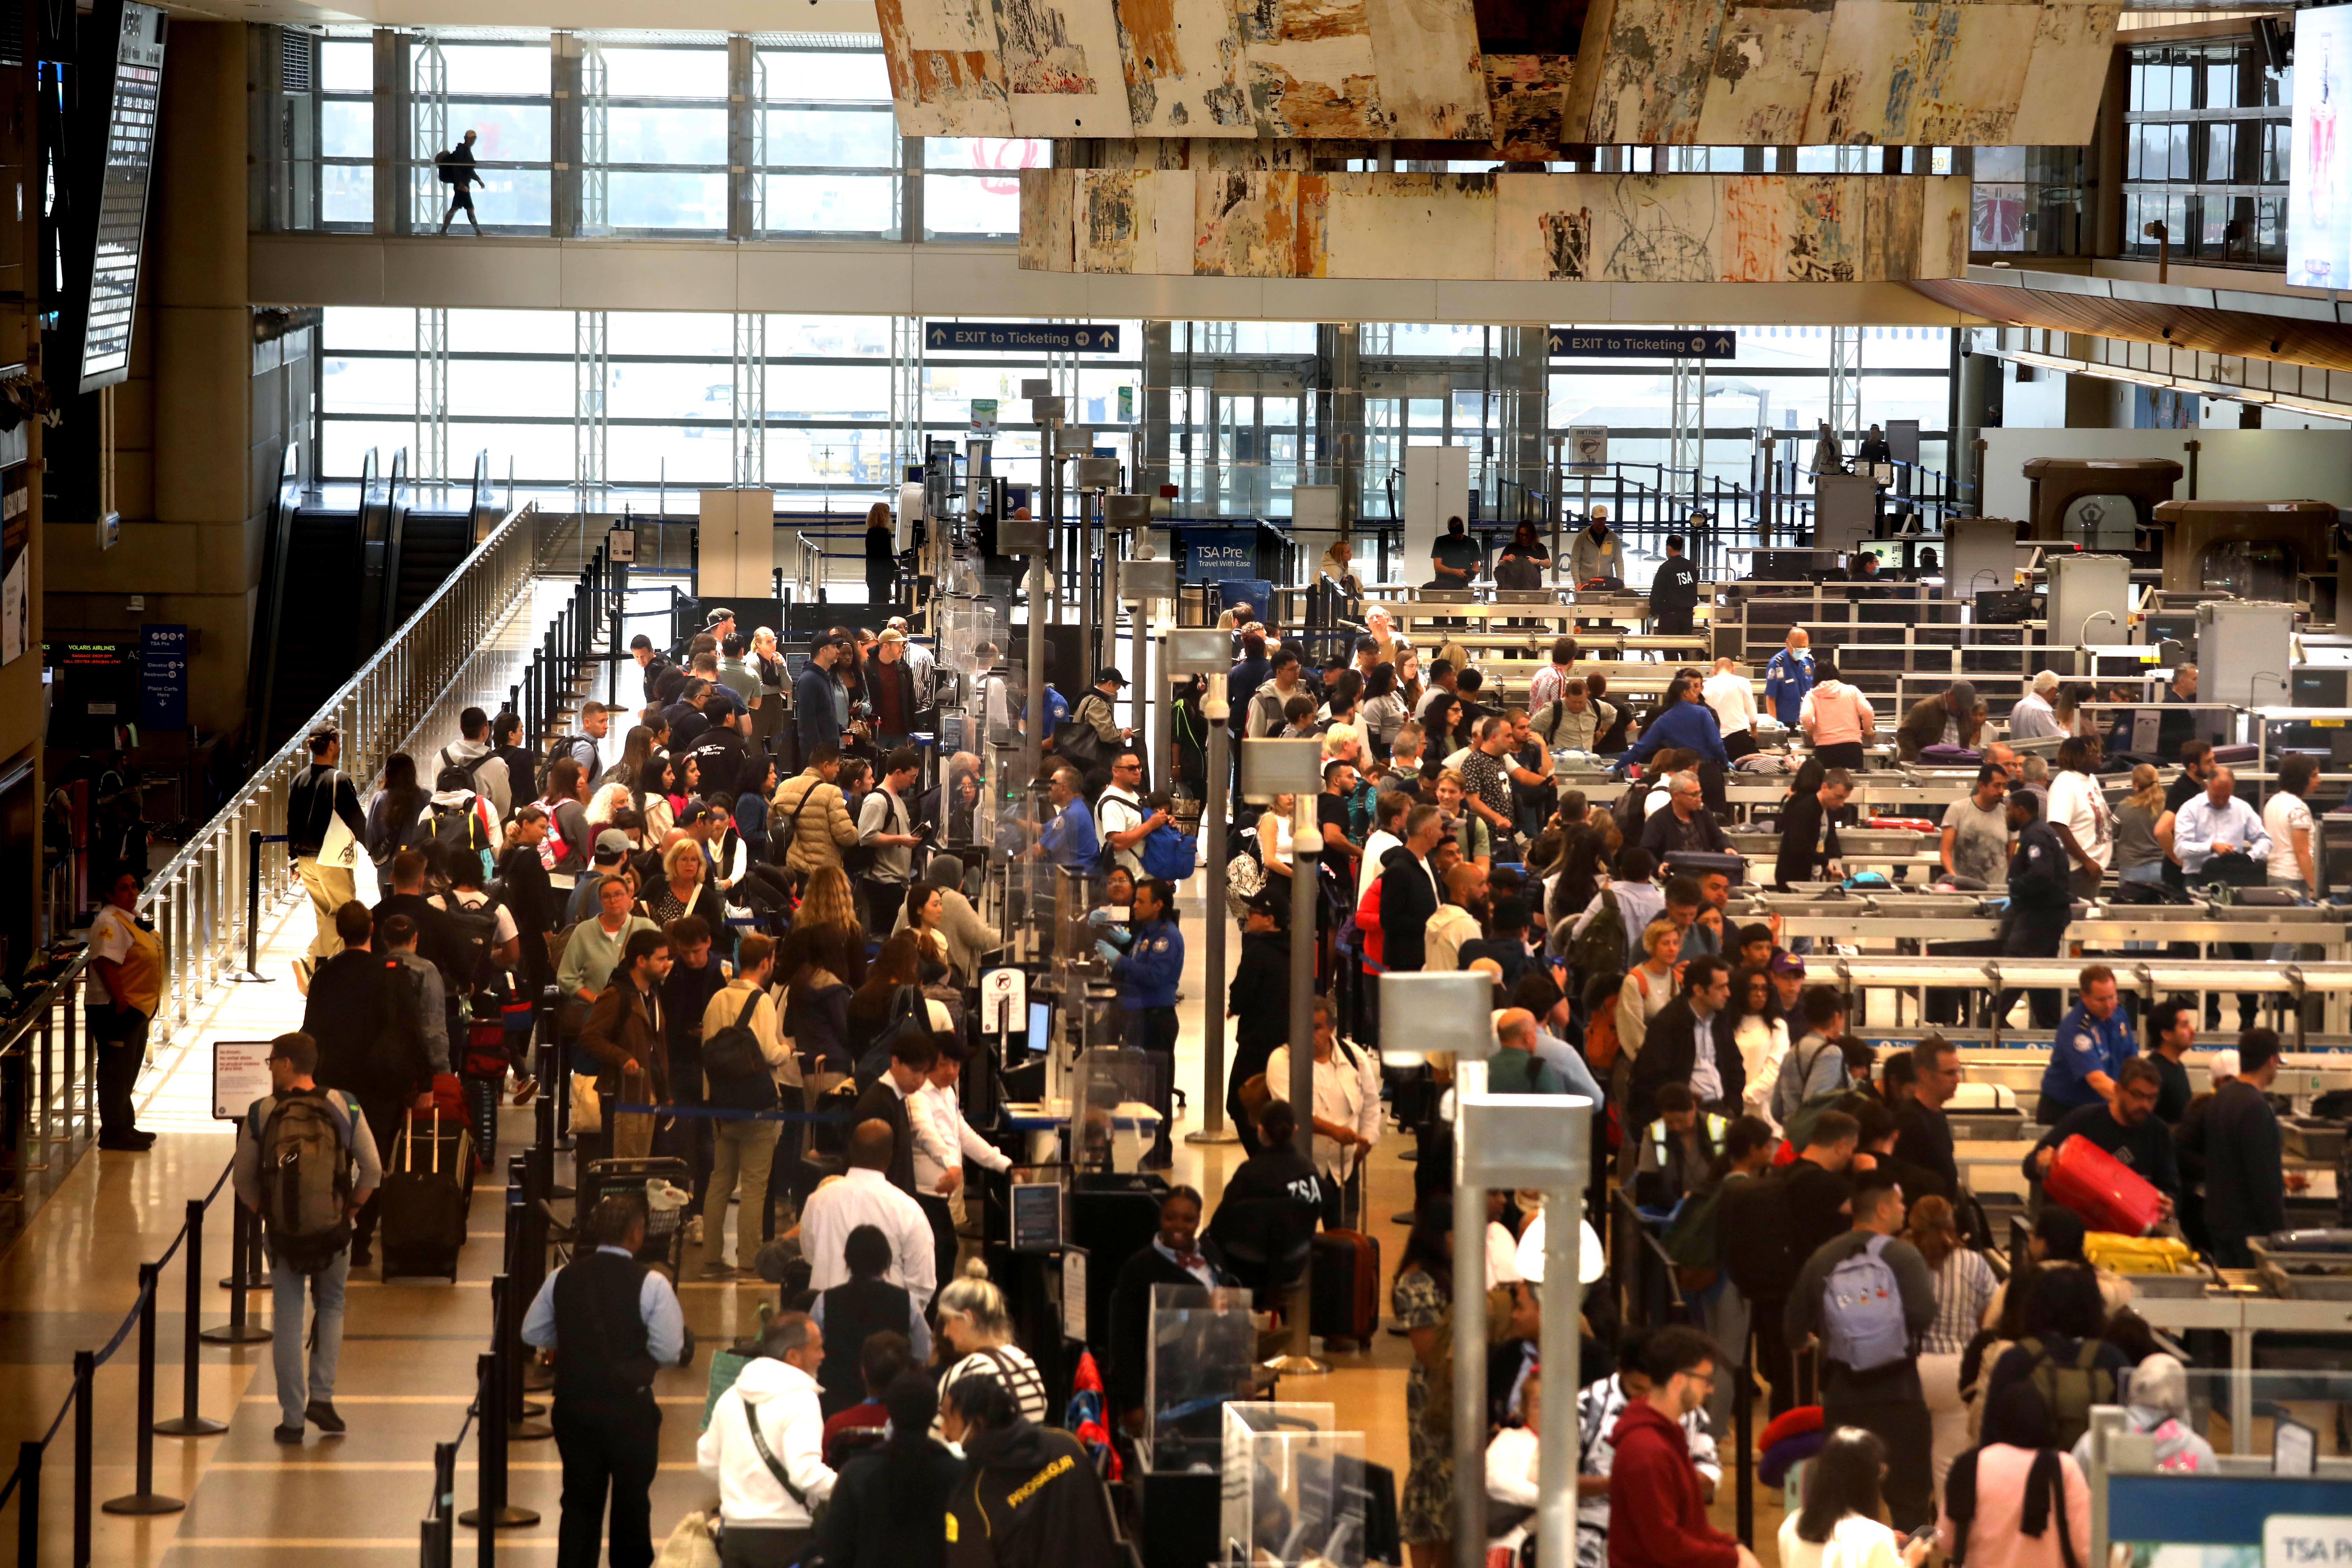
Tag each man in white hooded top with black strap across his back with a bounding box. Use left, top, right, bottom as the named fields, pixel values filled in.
left=694, top=1312, right=835, bottom=1568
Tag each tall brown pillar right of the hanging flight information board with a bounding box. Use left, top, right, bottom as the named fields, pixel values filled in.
left=42, top=19, right=296, bottom=731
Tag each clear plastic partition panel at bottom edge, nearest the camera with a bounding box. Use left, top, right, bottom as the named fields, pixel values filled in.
left=1218, top=1401, right=1364, bottom=1568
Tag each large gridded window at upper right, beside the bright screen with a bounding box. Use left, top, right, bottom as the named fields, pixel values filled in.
left=2124, top=40, right=2291, bottom=268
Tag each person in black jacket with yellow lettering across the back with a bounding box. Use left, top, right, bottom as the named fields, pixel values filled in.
left=938, top=1378, right=1120, bottom=1568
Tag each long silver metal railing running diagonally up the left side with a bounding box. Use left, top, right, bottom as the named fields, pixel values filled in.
left=0, top=505, right=539, bottom=1201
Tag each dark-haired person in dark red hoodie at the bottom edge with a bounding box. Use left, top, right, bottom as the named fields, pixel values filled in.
left=1609, top=1328, right=1757, bottom=1568
